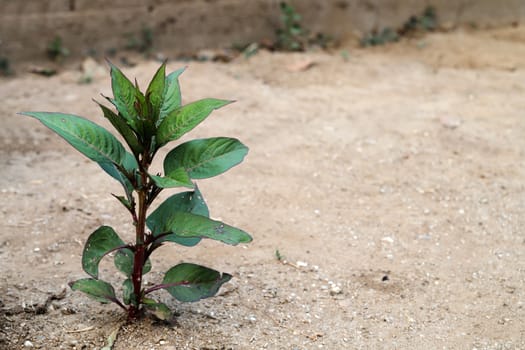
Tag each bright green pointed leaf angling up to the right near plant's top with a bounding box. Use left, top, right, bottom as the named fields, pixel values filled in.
left=157, top=98, right=233, bottom=147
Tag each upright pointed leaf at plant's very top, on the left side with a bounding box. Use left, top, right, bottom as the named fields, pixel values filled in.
left=110, top=63, right=140, bottom=131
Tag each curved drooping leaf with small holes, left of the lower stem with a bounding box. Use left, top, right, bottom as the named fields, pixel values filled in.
left=82, top=226, right=126, bottom=278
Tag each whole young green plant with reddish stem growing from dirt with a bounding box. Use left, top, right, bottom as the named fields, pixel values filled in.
left=22, top=64, right=252, bottom=321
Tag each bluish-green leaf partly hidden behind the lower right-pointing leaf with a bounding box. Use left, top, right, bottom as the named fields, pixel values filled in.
left=146, top=186, right=210, bottom=247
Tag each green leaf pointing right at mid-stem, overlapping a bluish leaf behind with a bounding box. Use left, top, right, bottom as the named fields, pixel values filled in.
left=164, top=212, right=252, bottom=245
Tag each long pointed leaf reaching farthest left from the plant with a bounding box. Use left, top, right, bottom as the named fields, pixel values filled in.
left=22, top=112, right=126, bottom=165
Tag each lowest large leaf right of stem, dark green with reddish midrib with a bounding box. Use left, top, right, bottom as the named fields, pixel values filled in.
left=162, top=263, right=232, bottom=302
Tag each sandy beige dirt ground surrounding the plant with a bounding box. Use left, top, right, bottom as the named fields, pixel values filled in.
left=0, top=27, right=525, bottom=350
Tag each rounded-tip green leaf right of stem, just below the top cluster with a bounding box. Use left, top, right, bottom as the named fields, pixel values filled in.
left=164, top=137, right=248, bottom=179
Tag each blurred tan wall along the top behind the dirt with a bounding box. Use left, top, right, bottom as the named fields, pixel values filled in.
left=0, top=0, right=525, bottom=60
